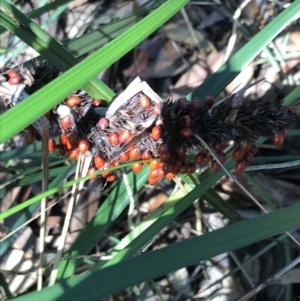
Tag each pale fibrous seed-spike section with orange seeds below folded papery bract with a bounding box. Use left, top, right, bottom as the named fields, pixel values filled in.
left=72, top=93, right=163, bottom=182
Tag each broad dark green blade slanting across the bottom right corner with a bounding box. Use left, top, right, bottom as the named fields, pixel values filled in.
left=11, top=205, right=300, bottom=301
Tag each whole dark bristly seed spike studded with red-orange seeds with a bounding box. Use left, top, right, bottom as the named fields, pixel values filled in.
left=4, top=64, right=297, bottom=184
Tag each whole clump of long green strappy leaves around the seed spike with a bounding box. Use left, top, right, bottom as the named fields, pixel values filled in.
left=0, top=0, right=300, bottom=300
